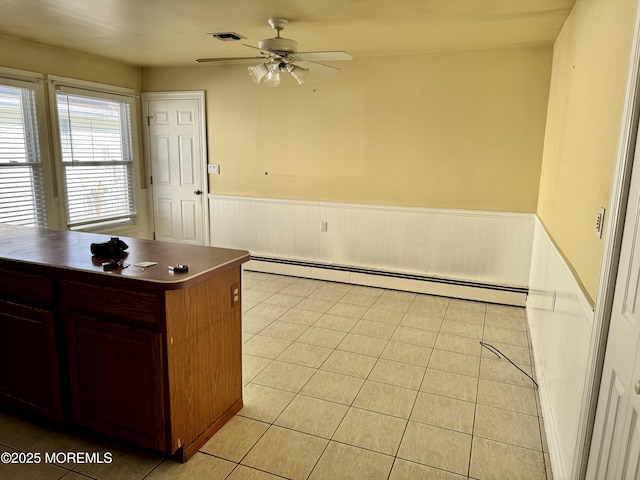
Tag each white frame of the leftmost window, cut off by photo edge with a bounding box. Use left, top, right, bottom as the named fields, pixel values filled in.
left=0, top=67, right=50, bottom=228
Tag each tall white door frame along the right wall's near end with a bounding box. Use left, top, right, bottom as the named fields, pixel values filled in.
left=573, top=2, right=640, bottom=478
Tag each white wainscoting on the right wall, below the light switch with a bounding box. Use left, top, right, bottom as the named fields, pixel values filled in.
left=527, top=219, right=594, bottom=480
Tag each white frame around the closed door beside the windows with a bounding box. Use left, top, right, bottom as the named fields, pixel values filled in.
left=140, top=90, right=210, bottom=246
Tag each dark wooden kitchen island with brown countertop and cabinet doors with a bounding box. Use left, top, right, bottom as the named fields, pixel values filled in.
left=0, top=225, right=249, bottom=461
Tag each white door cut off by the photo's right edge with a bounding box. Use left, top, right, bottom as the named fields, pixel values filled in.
left=587, top=126, right=640, bottom=480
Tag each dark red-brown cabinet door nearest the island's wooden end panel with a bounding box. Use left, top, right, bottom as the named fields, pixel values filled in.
left=67, top=315, right=166, bottom=451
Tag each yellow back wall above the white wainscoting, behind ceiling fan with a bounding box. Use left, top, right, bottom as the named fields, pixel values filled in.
left=142, top=47, right=552, bottom=212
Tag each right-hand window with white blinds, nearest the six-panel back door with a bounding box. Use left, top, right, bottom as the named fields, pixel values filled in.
left=54, top=78, right=136, bottom=229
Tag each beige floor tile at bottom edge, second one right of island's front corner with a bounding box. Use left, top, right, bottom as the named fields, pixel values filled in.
left=241, top=426, right=329, bottom=480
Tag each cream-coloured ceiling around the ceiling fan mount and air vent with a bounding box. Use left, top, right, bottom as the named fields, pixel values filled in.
left=0, top=0, right=575, bottom=66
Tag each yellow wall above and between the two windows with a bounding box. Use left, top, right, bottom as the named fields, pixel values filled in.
left=0, top=36, right=149, bottom=237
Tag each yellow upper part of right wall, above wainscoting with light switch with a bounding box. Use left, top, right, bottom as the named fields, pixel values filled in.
left=538, top=0, right=636, bottom=299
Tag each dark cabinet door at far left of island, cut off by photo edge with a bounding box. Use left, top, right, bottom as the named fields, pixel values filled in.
left=0, top=300, right=62, bottom=421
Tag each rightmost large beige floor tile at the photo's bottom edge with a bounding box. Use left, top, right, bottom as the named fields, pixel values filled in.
left=469, top=437, right=546, bottom=480
